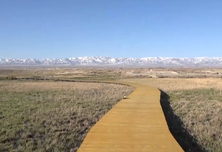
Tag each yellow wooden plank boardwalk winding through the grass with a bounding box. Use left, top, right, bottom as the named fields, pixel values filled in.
left=78, top=84, right=183, bottom=152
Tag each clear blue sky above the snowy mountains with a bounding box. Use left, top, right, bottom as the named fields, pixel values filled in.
left=0, top=0, right=222, bottom=58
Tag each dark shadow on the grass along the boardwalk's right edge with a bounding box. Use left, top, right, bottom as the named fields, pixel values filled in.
left=159, top=89, right=206, bottom=152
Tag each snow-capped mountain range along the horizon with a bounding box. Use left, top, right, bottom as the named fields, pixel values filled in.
left=0, top=56, right=222, bottom=67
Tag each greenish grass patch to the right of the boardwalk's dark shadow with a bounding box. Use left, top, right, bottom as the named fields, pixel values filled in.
left=168, top=88, right=222, bottom=152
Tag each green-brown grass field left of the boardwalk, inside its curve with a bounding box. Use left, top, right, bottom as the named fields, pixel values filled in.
left=0, top=81, right=133, bottom=152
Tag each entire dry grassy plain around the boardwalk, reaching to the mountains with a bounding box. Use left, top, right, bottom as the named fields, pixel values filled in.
left=0, top=67, right=222, bottom=152
